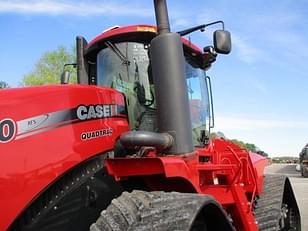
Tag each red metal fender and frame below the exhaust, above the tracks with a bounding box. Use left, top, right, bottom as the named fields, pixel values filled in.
left=106, top=139, right=263, bottom=231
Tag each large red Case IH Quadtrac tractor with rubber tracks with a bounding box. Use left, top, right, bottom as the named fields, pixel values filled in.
left=0, top=0, right=300, bottom=231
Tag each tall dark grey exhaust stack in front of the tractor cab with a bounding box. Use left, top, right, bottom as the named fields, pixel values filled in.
left=150, top=0, right=194, bottom=154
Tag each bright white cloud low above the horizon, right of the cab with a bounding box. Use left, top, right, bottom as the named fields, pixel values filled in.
left=215, top=115, right=308, bottom=156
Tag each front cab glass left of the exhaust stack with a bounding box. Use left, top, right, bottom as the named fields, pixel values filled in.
left=97, top=42, right=156, bottom=131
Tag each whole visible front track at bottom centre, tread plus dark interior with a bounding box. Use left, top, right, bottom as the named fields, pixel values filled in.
left=90, top=191, right=234, bottom=231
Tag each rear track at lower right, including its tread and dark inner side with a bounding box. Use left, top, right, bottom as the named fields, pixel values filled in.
left=254, top=175, right=301, bottom=231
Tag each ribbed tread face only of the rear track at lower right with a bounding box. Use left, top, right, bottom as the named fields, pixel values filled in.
left=254, top=175, right=286, bottom=231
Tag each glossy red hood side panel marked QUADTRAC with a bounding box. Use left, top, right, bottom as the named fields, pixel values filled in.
left=0, top=85, right=128, bottom=230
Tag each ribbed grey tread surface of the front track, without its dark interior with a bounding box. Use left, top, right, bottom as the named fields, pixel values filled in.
left=90, top=191, right=230, bottom=231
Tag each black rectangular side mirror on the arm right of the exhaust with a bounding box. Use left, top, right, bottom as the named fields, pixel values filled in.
left=213, top=30, right=231, bottom=54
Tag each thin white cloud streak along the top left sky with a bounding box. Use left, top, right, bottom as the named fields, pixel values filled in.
left=0, top=0, right=153, bottom=17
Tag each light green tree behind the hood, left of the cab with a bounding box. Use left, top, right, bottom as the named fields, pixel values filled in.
left=21, top=46, right=77, bottom=86
